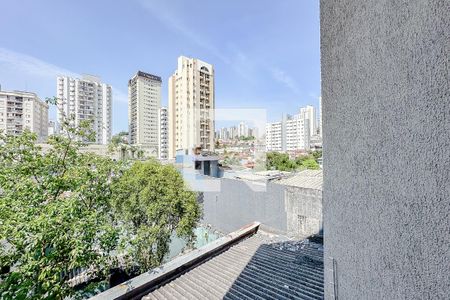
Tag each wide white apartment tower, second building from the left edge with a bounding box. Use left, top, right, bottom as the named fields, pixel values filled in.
left=56, top=75, right=112, bottom=144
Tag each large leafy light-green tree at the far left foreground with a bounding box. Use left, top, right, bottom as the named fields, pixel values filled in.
left=0, top=122, right=120, bottom=299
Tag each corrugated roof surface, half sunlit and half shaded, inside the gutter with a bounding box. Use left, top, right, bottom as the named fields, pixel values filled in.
left=142, top=233, right=324, bottom=300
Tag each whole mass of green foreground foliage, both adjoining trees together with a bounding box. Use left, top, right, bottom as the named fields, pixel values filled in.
left=0, top=100, right=200, bottom=299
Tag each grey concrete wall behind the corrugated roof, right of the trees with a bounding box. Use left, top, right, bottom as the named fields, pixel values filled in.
left=202, top=178, right=322, bottom=237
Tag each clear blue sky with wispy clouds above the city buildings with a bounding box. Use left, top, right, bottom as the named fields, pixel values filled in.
left=0, top=0, right=320, bottom=133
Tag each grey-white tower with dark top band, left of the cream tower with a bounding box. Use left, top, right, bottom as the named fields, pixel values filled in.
left=128, top=71, right=162, bottom=156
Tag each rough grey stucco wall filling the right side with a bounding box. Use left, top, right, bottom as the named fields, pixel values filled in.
left=320, top=0, right=450, bottom=299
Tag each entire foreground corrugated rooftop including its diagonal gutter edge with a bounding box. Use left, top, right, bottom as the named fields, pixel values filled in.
left=91, top=223, right=324, bottom=300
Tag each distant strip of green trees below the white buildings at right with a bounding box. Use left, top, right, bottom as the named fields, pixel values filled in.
left=266, top=151, right=322, bottom=171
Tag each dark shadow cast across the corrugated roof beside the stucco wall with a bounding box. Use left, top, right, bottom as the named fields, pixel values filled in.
left=222, top=236, right=324, bottom=299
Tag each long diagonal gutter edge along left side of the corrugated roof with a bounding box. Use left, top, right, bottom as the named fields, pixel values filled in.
left=90, top=222, right=260, bottom=300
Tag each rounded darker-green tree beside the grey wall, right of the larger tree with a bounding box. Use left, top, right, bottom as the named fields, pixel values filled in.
left=112, top=160, right=200, bottom=271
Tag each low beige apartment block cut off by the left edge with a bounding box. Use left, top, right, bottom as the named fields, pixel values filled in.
left=0, top=91, right=48, bottom=143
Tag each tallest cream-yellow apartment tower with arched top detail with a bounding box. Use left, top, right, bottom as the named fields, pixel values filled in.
left=168, top=56, right=215, bottom=158
